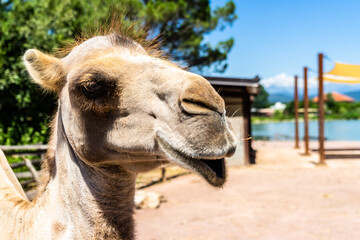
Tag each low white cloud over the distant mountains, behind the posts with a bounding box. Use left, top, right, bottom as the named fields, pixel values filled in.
left=260, top=72, right=317, bottom=90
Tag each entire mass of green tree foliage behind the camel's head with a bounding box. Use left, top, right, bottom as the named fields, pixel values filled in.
left=0, top=0, right=236, bottom=144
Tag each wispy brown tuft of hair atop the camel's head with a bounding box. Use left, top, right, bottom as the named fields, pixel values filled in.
left=55, top=14, right=170, bottom=60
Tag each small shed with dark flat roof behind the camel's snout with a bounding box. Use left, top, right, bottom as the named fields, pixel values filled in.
left=204, top=76, right=260, bottom=166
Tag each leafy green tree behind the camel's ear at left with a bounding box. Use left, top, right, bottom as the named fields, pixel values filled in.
left=0, top=0, right=114, bottom=144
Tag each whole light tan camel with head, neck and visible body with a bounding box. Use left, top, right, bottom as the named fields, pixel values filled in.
left=0, top=25, right=236, bottom=240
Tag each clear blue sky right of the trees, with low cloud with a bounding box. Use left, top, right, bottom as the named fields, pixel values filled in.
left=205, top=0, right=360, bottom=95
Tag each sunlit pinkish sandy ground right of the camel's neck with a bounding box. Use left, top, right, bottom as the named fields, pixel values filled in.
left=136, top=141, right=360, bottom=240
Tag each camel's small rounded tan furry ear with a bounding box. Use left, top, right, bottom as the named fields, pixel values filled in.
left=24, top=49, right=65, bottom=92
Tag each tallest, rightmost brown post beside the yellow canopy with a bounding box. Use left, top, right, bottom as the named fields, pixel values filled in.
left=318, top=53, right=325, bottom=165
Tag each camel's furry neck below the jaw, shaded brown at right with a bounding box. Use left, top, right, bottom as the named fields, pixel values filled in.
left=43, top=109, right=136, bottom=240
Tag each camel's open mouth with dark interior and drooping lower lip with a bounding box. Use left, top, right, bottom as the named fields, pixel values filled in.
left=158, top=137, right=226, bottom=187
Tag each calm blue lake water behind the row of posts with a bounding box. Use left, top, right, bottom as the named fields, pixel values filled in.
left=252, top=120, right=360, bottom=141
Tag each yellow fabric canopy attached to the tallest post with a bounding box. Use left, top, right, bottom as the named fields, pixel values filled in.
left=324, top=62, right=360, bottom=83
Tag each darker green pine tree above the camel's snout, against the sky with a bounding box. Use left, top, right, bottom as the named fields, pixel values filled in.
left=142, top=0, right=236, bottom=72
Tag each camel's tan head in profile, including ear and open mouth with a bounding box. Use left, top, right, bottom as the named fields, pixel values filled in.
left=24, top=34, right=236, bottom=186
